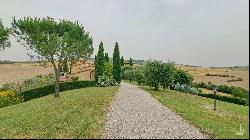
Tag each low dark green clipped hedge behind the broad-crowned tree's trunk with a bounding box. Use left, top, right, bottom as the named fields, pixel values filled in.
left=21, top=81, right=96, bottom=101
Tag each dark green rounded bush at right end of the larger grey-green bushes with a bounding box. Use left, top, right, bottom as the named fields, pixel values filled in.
left=174, top=69, right=193, bottom=85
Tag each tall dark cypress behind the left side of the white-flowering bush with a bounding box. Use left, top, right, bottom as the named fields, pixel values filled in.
left=95, top=42, right=105, bottom=81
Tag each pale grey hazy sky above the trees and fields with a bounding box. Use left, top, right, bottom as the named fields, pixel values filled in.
left=0, top=0, right=249, bottom=66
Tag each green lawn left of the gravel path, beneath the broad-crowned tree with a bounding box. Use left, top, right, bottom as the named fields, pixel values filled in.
left=0, top=87, right=118, bottom=138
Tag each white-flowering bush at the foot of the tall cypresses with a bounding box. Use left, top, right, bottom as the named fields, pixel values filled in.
left=96, top=75, right=116, bottom=87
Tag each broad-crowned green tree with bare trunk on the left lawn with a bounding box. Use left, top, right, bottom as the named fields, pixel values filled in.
left=12, top=17, right=94, bottom=97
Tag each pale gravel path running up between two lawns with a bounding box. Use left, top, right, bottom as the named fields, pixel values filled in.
left=102, top=83, right=209, bottom=139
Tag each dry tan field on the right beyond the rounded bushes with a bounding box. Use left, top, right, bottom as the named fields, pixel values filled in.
left=177, top=65, right=249, bottom=89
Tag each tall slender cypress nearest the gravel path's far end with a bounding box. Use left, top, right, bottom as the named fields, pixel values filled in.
left=113, top=42, right=121, bottom=84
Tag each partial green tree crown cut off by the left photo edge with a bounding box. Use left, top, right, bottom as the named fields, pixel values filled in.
left=0, top=19, right=10, bottom=51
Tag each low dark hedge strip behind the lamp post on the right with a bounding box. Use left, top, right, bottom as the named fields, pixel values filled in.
left=198, top=93, right=249, bottom=106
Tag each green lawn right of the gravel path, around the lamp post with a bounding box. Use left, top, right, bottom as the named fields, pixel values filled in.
left=141, top=86, right=249, bottom=139
